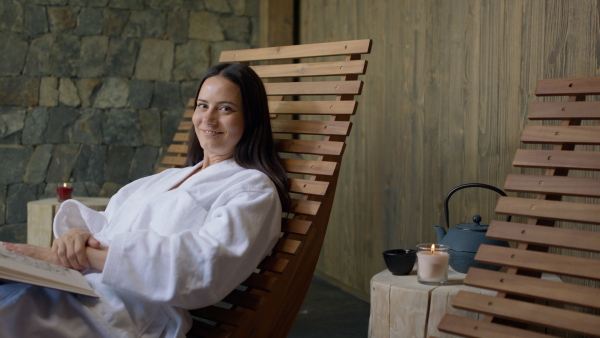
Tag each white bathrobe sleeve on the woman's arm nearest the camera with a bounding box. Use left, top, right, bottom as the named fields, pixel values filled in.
left=102, top=175, right=281, bottom=309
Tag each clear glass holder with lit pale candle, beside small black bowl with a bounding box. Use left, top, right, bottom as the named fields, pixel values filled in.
left=417, top=243, right=450, bottom=285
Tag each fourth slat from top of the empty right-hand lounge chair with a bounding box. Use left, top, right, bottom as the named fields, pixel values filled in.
left=513, top=149, right=600, bottom=170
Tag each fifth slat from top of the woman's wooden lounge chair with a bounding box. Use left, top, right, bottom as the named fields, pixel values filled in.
left=271, top=120, right=352, bottom=136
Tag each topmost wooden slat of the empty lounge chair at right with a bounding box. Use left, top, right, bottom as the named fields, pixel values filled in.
left=535, top=77, right=600, bottom=96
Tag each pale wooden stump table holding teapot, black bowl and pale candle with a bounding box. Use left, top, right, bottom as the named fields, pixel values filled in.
left=369, top=269, right=496, bottom=338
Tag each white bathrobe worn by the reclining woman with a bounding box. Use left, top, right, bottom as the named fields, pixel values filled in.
left=0, top=159, right=281, bottom=337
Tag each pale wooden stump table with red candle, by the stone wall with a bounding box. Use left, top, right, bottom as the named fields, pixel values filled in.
left=27, top=197, right=110, bottom=247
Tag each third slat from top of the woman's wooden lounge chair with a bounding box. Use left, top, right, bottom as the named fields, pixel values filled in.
left=265, top=80, right=363, bottom=95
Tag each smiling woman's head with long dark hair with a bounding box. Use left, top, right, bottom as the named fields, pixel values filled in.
left=186, top=63, right=290, bottom=211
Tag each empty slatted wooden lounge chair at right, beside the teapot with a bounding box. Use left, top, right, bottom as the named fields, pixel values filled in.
left=438, top=77, right=600, bottom=337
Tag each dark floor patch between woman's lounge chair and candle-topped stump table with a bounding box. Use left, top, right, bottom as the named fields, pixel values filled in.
left=288, top=277, right=369, bottom=338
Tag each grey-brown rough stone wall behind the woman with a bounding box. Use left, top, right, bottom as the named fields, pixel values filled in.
left=0, top=0, right=258, bottom=242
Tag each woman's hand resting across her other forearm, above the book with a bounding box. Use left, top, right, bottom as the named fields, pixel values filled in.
left=51, top=228, right=100, bottom=270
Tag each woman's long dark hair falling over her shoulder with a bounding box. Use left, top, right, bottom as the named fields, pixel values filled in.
left=186, top=63, right=291, bottom=211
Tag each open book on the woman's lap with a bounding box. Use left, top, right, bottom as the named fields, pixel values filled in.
left=0, top=245, right=98, bottom=297
